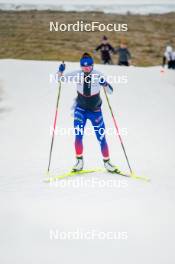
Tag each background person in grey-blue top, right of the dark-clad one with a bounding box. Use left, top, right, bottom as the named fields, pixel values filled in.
left=115, top=41, right=131, bottom=66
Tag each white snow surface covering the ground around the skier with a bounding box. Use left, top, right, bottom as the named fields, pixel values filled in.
left=0, top=60, right=175, bottom=264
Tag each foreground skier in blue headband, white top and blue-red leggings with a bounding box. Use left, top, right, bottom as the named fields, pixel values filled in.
left=58, top=53, right=117, bottom=172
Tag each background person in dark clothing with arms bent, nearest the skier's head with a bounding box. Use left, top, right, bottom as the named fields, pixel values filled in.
left=94, top=36, right=114, bottom=64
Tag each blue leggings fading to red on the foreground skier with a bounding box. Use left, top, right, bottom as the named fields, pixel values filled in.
left=74, top=106, right=109, bottom=159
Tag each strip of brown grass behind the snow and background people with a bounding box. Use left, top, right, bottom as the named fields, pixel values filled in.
left=0, top=11, right=175, bottom=66
